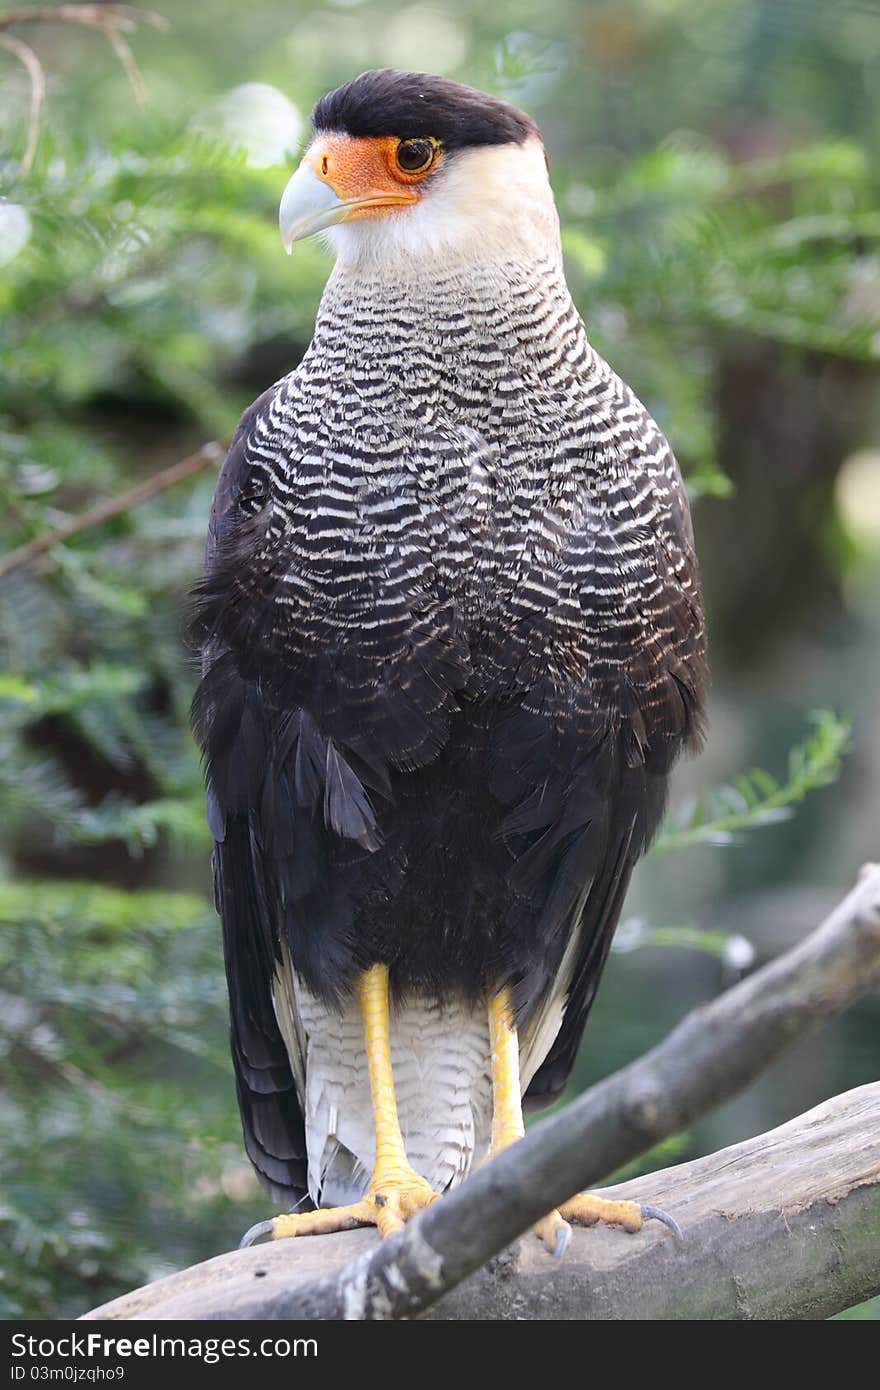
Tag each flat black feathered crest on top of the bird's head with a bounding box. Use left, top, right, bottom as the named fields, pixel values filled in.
left=311, top=68, right=541, bottom=150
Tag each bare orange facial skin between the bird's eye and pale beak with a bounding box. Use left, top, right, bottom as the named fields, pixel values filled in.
left=303, top=133, right=442, bottom=221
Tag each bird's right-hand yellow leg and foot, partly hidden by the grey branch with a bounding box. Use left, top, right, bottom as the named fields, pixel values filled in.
left=489, top=987, right=653, bottom=1255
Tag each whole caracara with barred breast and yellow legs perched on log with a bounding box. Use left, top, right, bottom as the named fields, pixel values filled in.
left=192, top=68, right=708, bottom=1254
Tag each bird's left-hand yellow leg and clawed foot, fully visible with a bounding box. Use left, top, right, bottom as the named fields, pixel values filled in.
left=242, top=965, right=438, bottom=1244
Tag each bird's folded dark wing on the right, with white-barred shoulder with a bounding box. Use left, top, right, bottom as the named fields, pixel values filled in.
left=505, top=388, right=706, bottom=1105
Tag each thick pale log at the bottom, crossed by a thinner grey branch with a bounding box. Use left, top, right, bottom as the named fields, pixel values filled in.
left=86, top=1083, right=880, bottom=1321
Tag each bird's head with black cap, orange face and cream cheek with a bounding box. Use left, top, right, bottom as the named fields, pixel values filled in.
left=279, top=68, right=559, bottom=264
